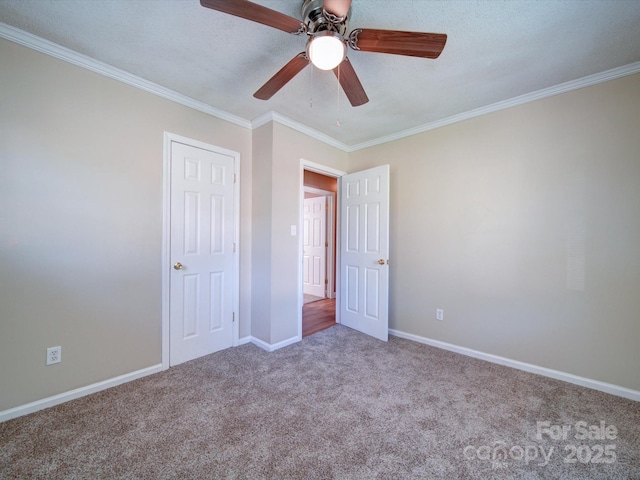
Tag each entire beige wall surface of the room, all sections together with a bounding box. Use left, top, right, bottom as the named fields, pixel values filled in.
left=0, top=31, right=640, bottom=411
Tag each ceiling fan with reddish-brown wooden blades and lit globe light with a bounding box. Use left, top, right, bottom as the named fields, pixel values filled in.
left=200, top=0, right=447, bottom=107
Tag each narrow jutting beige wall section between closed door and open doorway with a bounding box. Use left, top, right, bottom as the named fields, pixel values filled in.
left=252, top=123, right=347, bottom=345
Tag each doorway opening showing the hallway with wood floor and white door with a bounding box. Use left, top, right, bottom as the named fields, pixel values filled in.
left=301, top=168, right=338, bottom=338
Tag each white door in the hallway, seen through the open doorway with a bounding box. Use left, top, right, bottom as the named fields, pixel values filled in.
left=302, top=196, right=327, bottom=297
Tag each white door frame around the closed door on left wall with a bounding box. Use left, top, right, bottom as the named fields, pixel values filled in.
left=161, top=131, right=240, bottom=370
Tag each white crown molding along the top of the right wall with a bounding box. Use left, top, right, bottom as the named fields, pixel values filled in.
left=346, top=62, right=640, bottom=152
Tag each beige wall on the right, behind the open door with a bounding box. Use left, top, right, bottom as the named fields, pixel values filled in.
left=349, top=75, right=640, bottom=390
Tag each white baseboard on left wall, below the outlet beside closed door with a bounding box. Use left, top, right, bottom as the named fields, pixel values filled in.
left=0, top=364, right=163, bottom=423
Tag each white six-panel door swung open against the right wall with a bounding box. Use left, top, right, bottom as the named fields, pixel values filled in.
left=340, top=165, right=389, bottom=342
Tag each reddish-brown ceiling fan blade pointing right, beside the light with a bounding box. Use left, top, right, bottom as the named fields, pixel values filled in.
left=349, top=28, right=447, bottom=58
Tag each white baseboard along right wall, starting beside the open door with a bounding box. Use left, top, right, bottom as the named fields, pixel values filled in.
left=389, top=329, right=640, bottom=402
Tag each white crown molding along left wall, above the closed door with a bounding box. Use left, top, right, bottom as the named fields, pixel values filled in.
left=0, top=22, right=251, bottom=128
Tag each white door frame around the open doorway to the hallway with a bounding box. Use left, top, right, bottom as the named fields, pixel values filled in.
left=297, top=158, right=347, bottom=340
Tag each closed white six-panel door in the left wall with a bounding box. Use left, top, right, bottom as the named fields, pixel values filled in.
left=169, top=141, right=235, bottom=365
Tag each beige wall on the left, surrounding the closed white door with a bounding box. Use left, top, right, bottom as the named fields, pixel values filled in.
left=0, top=39, right=252, bottom=411
